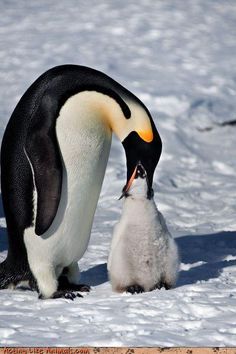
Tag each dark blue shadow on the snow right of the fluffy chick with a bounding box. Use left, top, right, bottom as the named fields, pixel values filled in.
left=176, top=231, right=236, bottom=287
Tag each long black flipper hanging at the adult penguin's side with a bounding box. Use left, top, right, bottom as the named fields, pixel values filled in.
left=25, top=127, right=62, bottom=236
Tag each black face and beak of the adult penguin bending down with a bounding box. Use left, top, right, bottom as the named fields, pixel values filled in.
left=122, top=124, right=162, bottom=199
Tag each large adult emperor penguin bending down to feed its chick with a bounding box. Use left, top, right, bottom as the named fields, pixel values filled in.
left=0, top=65, right=162, bottom=299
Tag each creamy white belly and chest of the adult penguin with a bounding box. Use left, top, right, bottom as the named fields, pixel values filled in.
left=24, top=94, right=111, bottom=270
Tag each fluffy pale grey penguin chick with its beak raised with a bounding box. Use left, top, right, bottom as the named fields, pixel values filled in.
left=108, top=164, right=179, bottom=294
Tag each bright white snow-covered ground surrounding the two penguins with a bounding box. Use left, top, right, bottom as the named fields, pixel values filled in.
left=0, top=0, right=236, bottom=346
